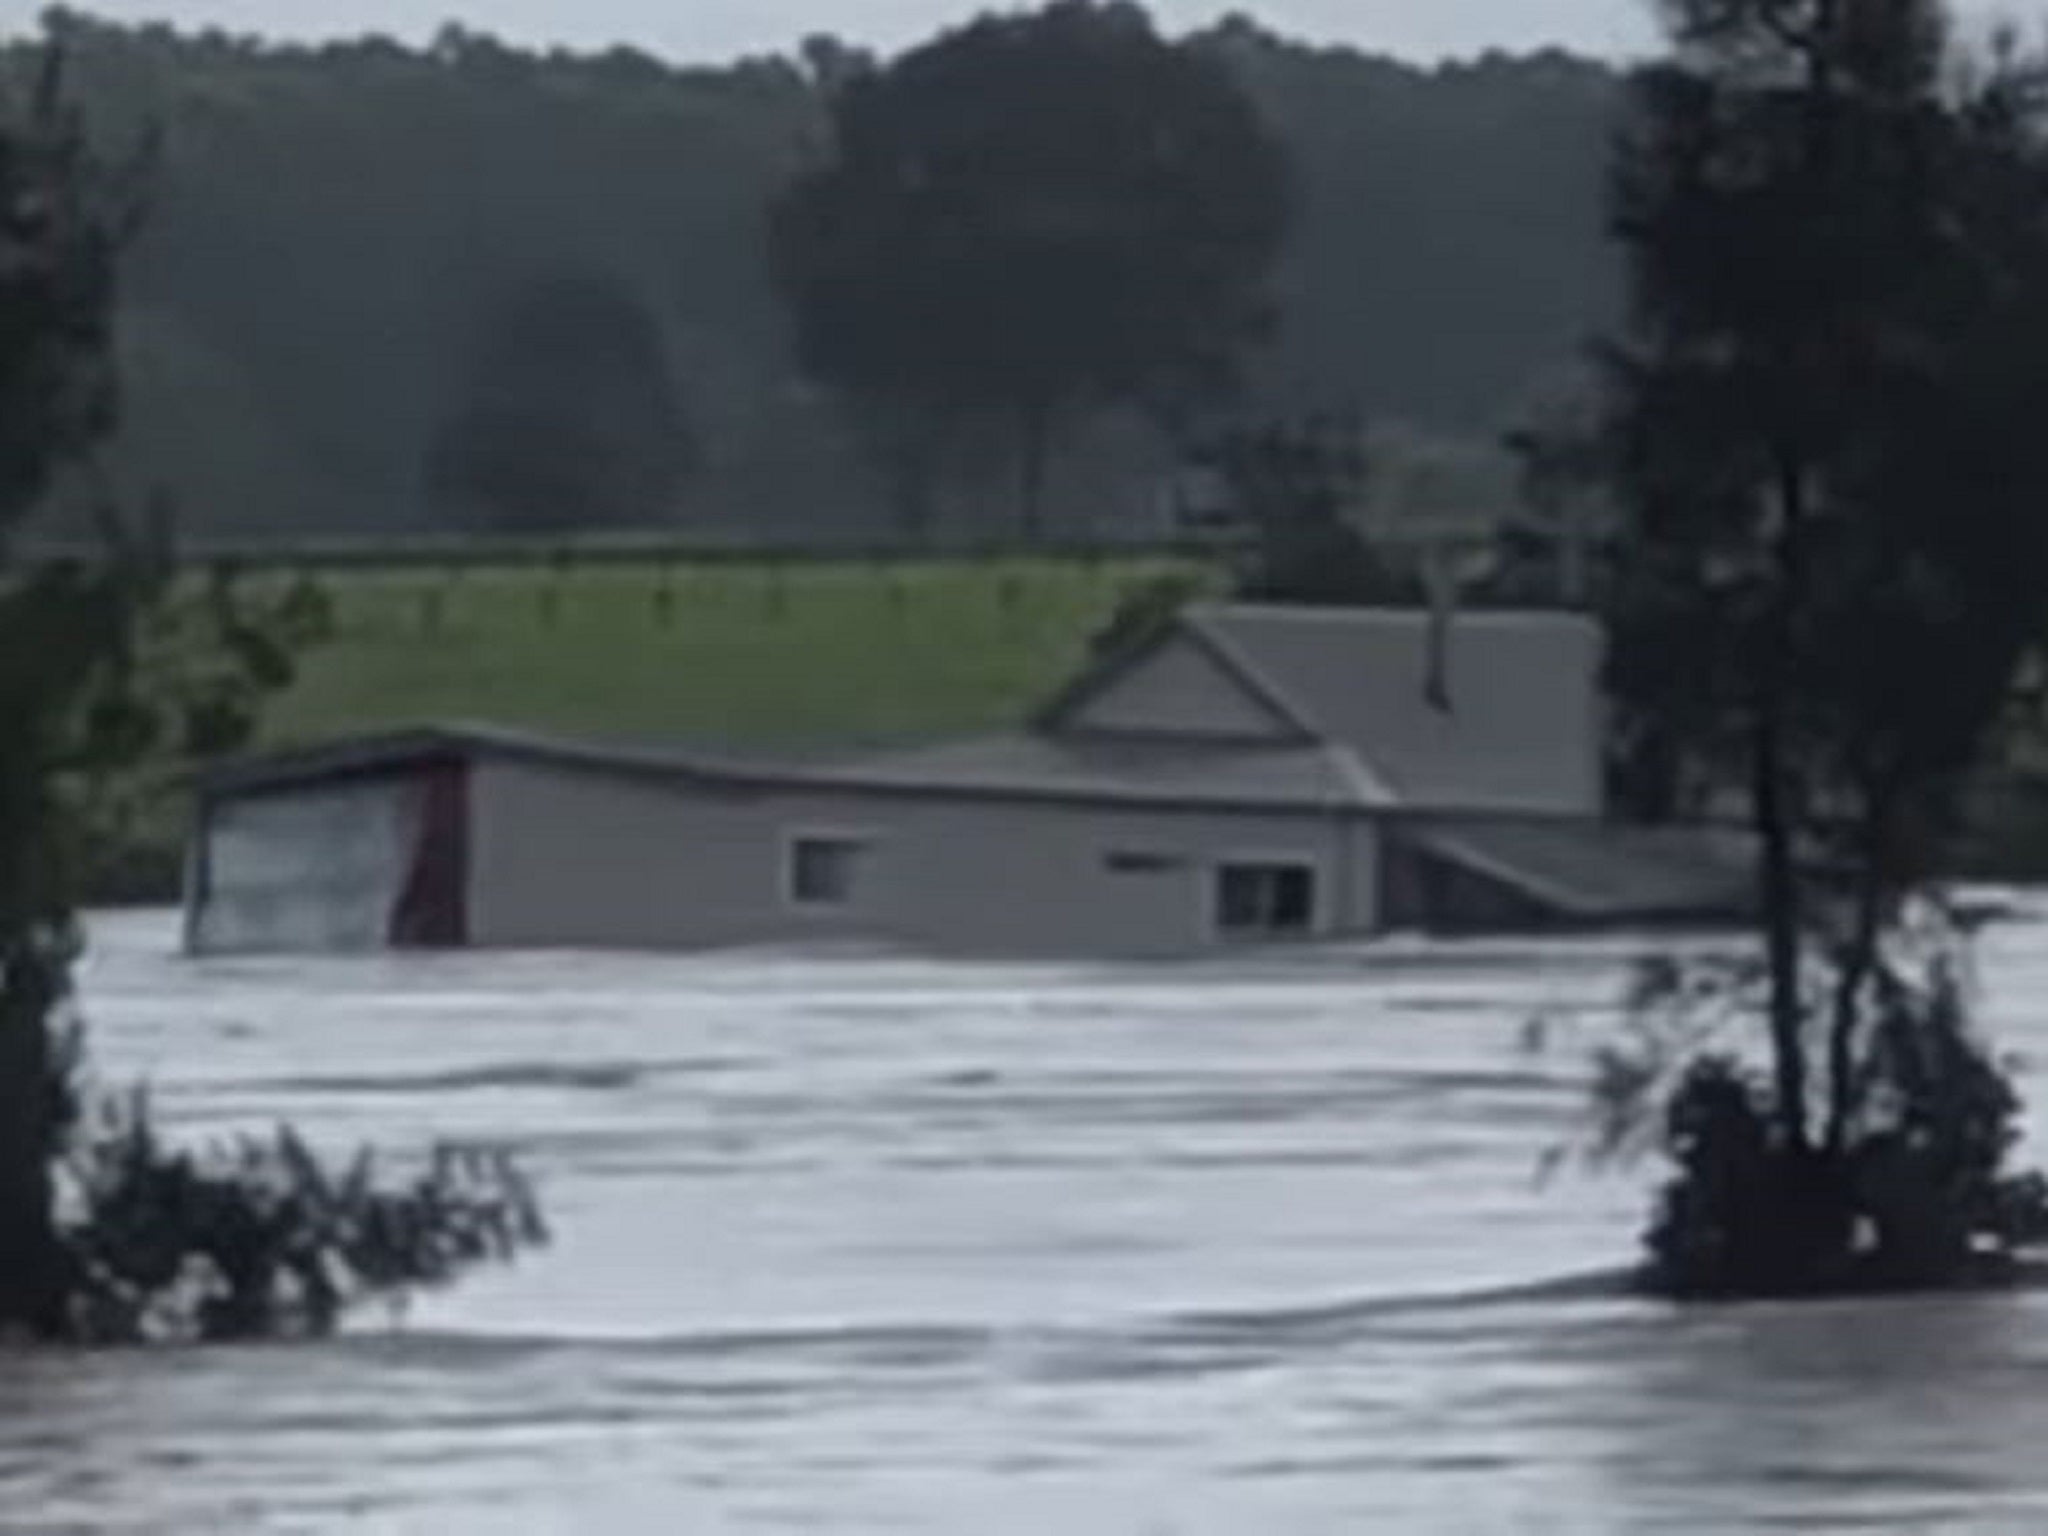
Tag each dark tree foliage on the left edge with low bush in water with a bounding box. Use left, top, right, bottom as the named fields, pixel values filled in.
left=0, top=47, right=539, bottom=1339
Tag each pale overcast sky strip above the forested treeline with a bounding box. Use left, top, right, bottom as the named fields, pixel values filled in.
left=0, top=0, right=2023, bottom=59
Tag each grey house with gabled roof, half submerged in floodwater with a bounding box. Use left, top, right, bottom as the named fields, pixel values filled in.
left=186, top=604, right=1749, bottom=956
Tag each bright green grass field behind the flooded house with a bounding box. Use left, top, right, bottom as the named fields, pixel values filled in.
left=246, top=557, right=1200, bottom=745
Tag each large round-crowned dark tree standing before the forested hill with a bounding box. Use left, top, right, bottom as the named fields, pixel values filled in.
left=770, top=0, right=1288, bottom=532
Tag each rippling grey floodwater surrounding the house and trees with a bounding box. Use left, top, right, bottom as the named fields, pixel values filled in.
left=12, top=907, right=2048, bottom=1536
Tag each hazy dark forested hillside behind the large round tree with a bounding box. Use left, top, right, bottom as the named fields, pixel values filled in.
left=14, top=16, right=1620, bottom=541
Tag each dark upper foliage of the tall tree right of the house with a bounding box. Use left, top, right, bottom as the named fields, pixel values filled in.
left=1612, top=0, right=2048, bottom=876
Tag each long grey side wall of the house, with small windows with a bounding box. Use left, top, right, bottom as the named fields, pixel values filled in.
left=469, top=758, right=1378, bottom=956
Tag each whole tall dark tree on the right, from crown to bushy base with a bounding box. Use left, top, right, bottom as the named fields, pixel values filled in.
left=1612, top=0, right=2048, bottom=1288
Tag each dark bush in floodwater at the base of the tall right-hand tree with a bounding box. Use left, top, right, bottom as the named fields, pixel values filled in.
left=1556, top=909, right=2048, bottom=1298
